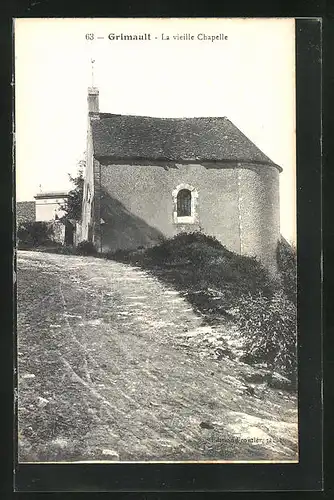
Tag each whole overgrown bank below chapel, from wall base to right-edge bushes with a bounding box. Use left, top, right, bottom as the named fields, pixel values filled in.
left=107, top=233, right=296, bottom=387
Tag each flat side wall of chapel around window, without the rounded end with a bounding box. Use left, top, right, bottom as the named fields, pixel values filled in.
left=96, top=165, right=240, bottom=252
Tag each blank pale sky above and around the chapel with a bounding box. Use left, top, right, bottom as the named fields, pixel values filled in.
left=14, top=18, right=296, bottom=243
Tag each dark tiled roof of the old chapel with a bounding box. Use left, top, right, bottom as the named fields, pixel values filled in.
left=91, top=113, right=281, bottom=170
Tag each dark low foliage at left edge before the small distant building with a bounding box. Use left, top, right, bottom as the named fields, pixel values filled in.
left=17, top=221, right=54, bottom=248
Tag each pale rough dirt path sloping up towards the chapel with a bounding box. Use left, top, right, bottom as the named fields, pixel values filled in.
left=18, top=252, right=297, bottom=461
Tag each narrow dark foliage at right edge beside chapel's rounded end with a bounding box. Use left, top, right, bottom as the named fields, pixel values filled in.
left=277, top=238, right=297, bottom=304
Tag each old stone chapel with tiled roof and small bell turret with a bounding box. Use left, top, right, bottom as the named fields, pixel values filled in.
left=79, top=87, right=282, bottom=267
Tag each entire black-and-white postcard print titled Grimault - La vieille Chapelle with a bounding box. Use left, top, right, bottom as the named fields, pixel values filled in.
left=14, top=18, right=299, bottom=464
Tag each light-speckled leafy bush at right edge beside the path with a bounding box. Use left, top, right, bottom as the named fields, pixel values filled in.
left=238, top=291, right=297, bottom=379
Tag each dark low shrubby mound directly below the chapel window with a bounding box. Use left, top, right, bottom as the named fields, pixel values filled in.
left=107, top=232, right=276, bottom=306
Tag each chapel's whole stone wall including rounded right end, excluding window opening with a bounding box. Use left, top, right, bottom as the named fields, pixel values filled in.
left=93, top=160, right=279, bottom=266
